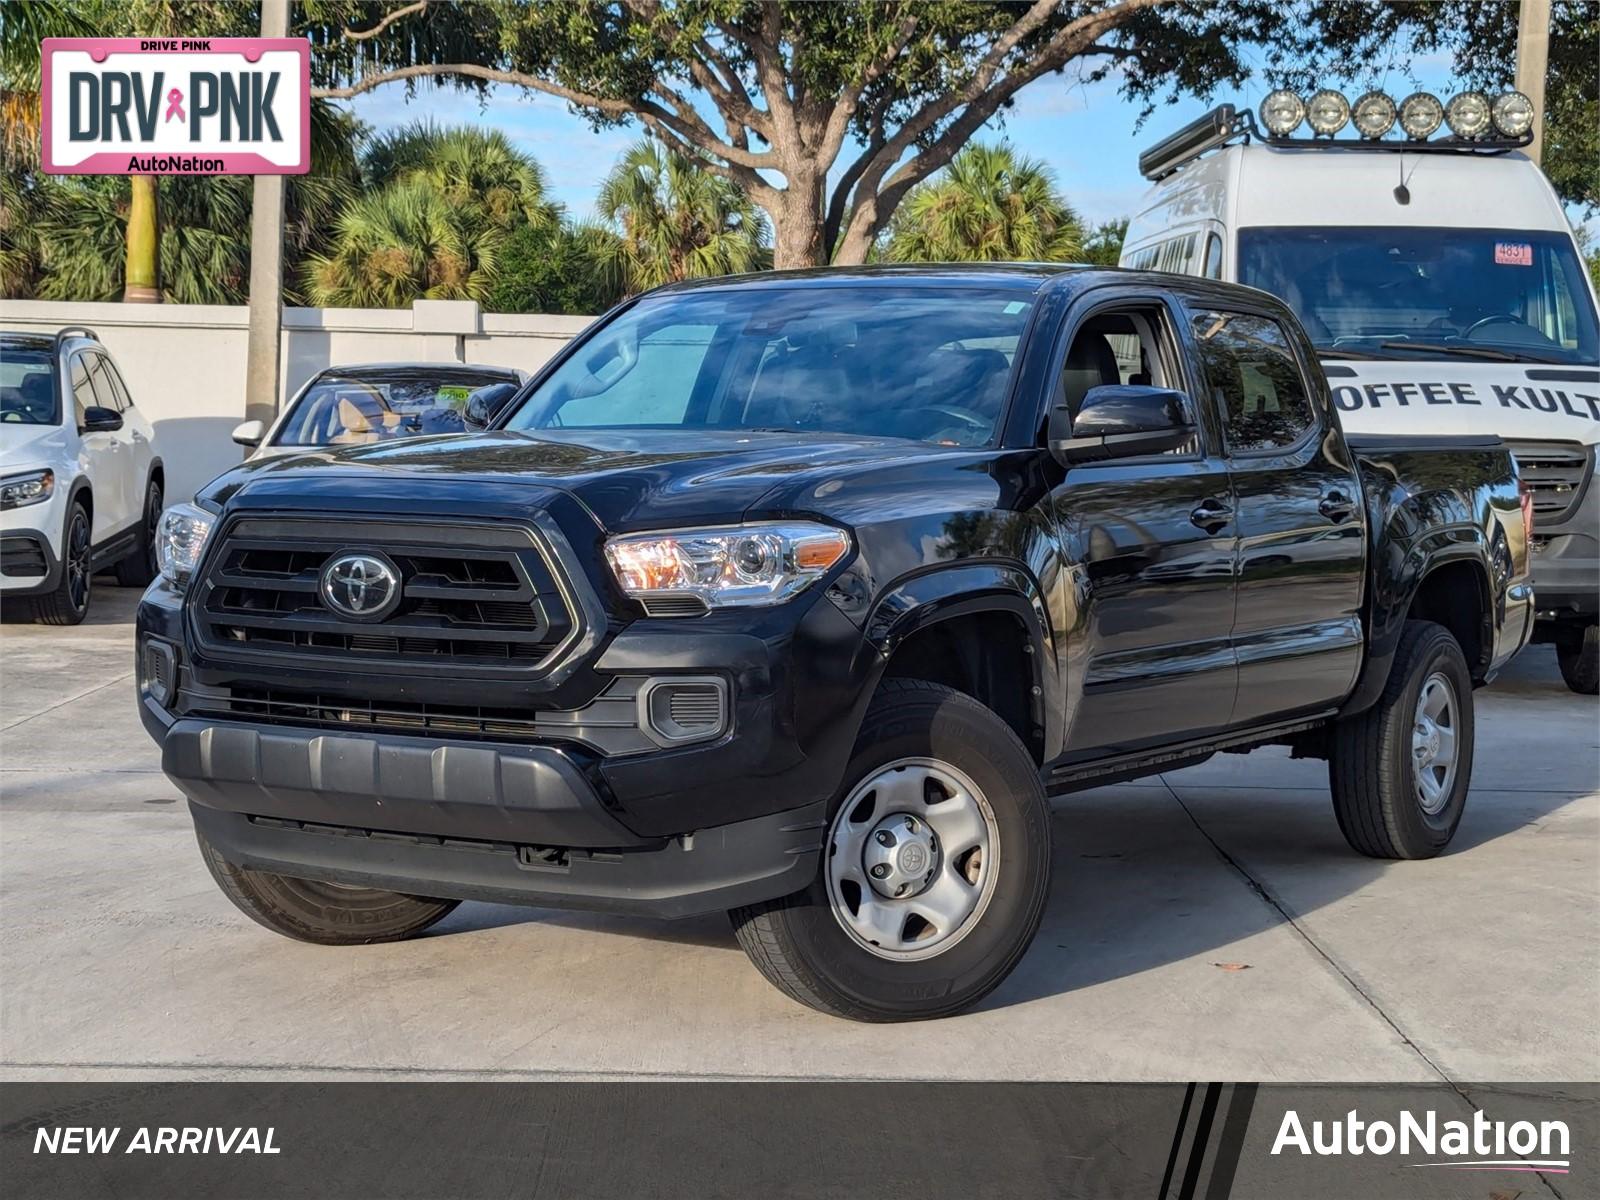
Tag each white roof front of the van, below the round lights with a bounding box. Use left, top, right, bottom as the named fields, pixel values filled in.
left=1131, top=142, right=1568, bottom=234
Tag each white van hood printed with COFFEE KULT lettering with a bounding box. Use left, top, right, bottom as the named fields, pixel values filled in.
left=1322, top=358, right=1600, bottom=445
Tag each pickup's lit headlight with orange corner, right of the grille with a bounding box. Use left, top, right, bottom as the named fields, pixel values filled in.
left=605, top=522, right=850, bottom=616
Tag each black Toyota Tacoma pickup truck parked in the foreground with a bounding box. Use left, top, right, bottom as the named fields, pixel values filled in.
left=138, top=266, right=1533, bottom=1021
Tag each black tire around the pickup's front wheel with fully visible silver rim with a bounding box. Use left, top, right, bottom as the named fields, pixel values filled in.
left=728, top=678, right=1051, bottom=1021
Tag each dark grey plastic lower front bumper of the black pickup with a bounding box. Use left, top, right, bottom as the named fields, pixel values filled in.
left=162, top=720, right=826, bottom=917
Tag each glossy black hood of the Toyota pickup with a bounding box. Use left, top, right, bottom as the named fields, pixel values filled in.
left=202, top=429, right=970, bottom=531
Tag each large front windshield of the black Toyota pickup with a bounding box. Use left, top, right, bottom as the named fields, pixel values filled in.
left=507, top=286, right=1034, bottom=446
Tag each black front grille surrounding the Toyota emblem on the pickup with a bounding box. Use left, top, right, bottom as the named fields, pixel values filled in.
left=195, top=517, right=574, bottom=672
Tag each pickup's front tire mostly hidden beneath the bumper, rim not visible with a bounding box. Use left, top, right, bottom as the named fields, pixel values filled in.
left=195, top=830, right=459, bottom=946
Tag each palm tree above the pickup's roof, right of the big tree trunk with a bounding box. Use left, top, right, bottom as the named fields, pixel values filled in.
left=885, top=142, right=1083, bottom=262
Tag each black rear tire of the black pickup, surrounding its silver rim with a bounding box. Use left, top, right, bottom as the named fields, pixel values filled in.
left=1328, top=621, right=1474, bottom=859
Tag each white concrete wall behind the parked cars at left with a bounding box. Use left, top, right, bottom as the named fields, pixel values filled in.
left=0, top=301, right=592, bottom=501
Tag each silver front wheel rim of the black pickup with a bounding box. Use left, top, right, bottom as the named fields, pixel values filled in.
left=826, top=758, right=1000, bottom=962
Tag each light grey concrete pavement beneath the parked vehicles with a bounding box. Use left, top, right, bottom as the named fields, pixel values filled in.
left=0, top=587, right=1600, bottom=1082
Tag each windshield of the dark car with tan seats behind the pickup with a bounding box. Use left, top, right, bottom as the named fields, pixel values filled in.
left=272, top=371, right=507, bottom=446
